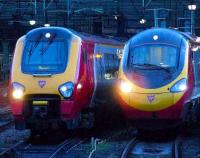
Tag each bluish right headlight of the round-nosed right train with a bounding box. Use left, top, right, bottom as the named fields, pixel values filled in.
left=170, top=78, right=187, bottom=93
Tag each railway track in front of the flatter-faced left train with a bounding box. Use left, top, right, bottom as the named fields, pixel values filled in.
left=0, top=139, right=86, bottom=158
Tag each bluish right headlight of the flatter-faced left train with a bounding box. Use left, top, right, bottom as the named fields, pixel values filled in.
left=58, top=82, right=74, bottom=98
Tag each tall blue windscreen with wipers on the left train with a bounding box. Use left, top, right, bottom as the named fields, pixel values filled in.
left=22, top=39, right=68, bottom=74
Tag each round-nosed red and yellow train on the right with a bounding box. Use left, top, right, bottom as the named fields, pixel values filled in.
left=116, top=28, right=200, bottom=129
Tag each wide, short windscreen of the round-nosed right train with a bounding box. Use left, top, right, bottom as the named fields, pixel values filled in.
left=128, top=45, right=179, bottom=69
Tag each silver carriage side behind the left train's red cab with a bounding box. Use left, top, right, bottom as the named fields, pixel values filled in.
left=94, top=44, right=119, bottom=104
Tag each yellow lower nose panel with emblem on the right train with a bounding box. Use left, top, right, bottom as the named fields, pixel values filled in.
left=130, top=93, right=173, bottom=111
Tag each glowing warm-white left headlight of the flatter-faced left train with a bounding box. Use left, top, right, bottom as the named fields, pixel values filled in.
left=12, top=82, right=25, bottom=99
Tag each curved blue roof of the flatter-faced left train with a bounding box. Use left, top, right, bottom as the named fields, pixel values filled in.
left=26, top=27, right=125, bottom=46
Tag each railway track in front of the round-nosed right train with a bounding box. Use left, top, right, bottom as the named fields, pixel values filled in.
left=121, top=137, right=183, bottom=158
